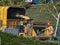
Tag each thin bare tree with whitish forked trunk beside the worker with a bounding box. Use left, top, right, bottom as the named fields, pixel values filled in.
left=49, top=0, right=60, bottom=36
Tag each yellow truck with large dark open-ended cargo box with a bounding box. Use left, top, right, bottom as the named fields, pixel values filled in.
left=0, top=6, right=25, bottom=30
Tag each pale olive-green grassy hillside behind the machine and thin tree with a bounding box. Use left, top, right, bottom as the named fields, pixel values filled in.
left=26, top=5, right=56, bottom=26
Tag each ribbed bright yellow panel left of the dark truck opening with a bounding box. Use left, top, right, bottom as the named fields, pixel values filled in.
left=0, top=6, right=9, bottom=30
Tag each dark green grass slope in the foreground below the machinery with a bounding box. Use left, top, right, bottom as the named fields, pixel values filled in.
left=0, top=32, right=57, bottom=45
